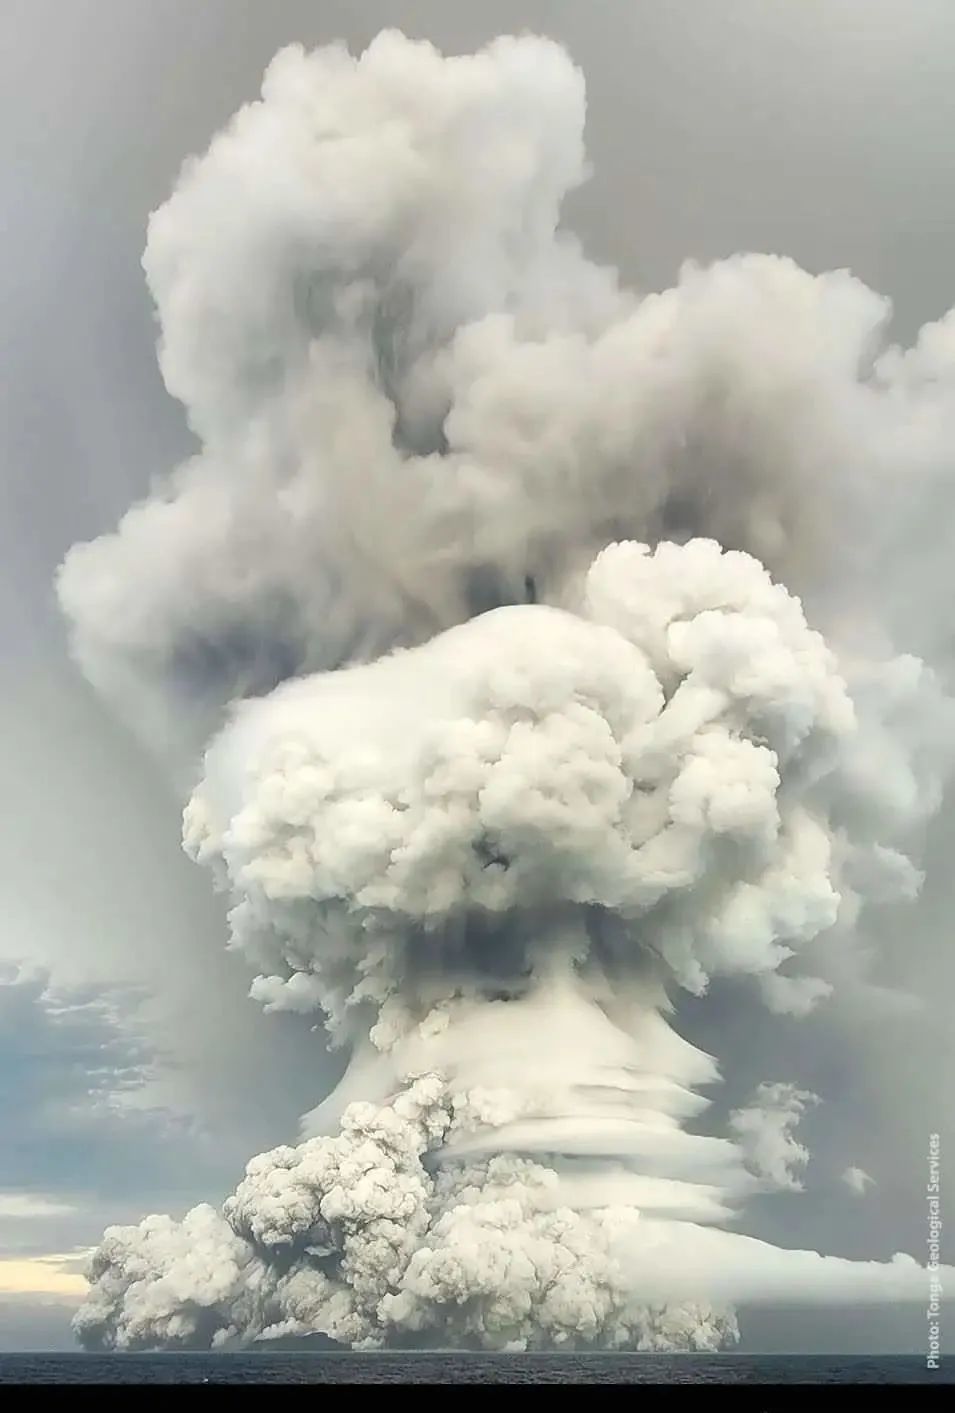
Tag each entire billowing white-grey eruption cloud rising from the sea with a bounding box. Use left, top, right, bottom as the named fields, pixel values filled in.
left=59, top=32, right=955, bottom=1348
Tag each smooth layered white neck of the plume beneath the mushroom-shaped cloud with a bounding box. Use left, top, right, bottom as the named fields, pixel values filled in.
left=307, top=916, right=747, bottom=1221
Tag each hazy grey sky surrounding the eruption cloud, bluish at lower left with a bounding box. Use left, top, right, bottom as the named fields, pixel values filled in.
left=0, top=0, right=955, bottom=1348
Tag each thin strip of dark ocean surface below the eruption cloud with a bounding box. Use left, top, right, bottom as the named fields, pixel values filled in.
left=0, top=1352, right=952, bottom=1385
